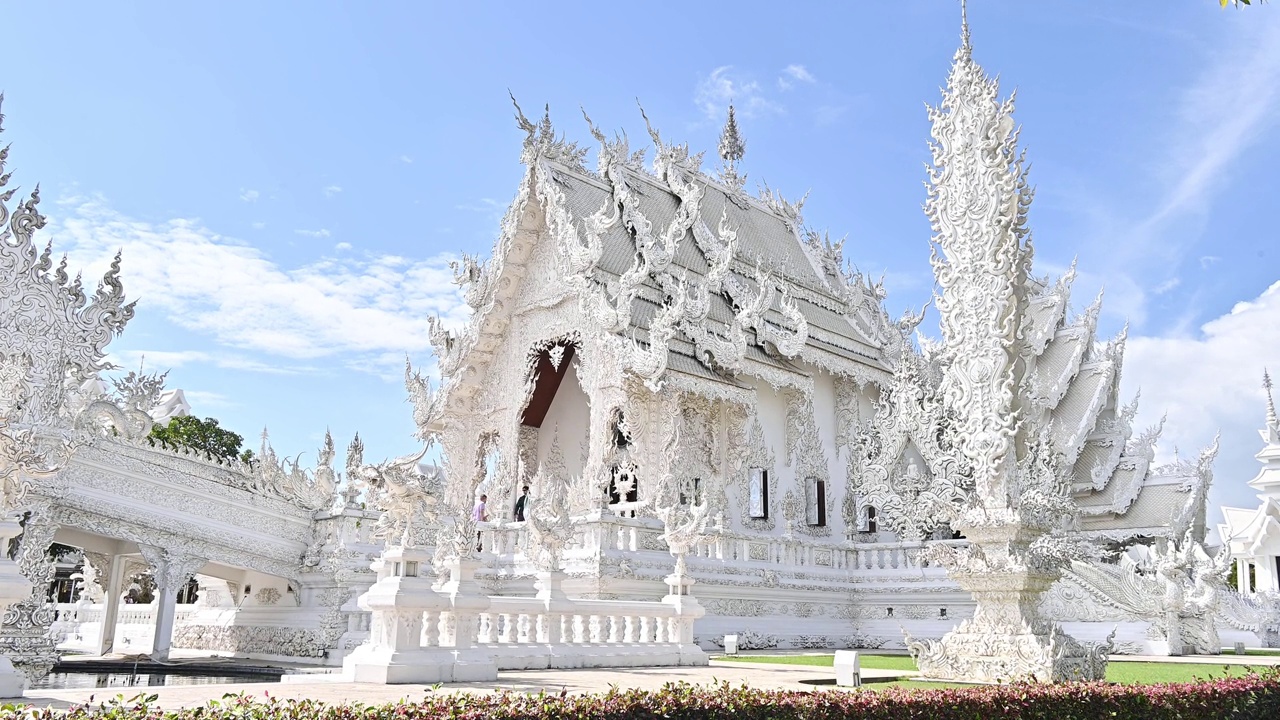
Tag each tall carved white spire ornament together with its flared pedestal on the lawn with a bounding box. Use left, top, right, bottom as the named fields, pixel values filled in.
left=908, top=11, right=1108, bottom=682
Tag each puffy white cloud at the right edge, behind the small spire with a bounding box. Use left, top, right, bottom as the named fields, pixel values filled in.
left=1123, top=282, right=1280, bottom=509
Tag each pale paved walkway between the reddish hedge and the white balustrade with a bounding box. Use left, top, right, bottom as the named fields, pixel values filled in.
left=10, top=661, right=915, bottom=708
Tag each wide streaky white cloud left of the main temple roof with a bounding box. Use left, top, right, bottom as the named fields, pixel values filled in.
left=51, top=197, right=467, bottom=369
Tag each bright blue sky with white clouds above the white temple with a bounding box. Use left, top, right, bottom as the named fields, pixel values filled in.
left=0, top=0, right=1280, bottom=524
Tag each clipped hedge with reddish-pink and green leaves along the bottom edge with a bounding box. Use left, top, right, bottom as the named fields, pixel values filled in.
left=0, top=670, right=1280, bottom=720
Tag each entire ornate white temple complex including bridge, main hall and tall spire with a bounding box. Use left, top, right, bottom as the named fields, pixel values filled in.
left=0, top=4, right=1280, bottom=694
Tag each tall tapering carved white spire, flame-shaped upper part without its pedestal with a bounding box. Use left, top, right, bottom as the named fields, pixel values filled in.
left=924, top=0, right=1034, bottom=491
